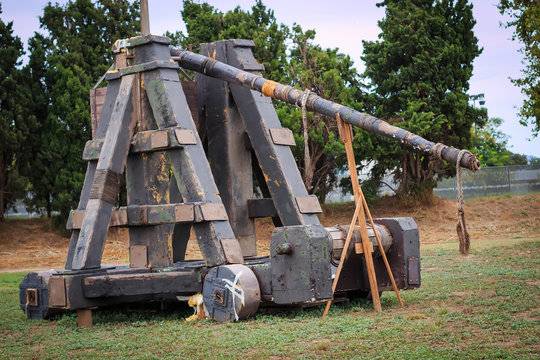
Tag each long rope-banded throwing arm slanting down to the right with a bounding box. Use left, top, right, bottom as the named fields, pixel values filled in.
left=171, top=48, right=480, bottom=171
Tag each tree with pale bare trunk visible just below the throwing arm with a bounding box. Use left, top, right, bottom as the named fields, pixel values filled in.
left=276, top=25, right=362, bottom=201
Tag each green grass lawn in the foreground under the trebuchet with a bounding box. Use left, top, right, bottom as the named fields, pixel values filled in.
left=0, top=239, right=540, bottom=359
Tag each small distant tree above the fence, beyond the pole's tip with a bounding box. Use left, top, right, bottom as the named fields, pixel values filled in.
left=471, top=118, right=527, bottom=166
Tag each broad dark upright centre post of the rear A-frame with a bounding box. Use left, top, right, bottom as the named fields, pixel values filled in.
left=197, top=42, right=257, bottom=257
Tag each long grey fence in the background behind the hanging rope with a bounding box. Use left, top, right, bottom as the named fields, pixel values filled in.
left=434, top=165, right=540, bottom=198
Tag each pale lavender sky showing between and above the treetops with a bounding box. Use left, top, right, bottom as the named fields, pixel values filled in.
left=0, top=0, right=540, bottom=156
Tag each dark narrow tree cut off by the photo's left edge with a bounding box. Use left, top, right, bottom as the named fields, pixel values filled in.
left=0, top=4, right=29, bottom=221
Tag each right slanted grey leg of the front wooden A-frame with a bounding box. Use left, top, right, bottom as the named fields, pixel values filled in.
left=143, top=61, right=243, bottom=266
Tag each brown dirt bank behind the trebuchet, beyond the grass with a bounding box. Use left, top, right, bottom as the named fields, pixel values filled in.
left=0, top=194, right=540, bottom=270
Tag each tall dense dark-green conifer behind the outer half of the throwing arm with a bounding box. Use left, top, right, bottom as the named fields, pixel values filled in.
left=362, top=0, right=486, bottom=195
